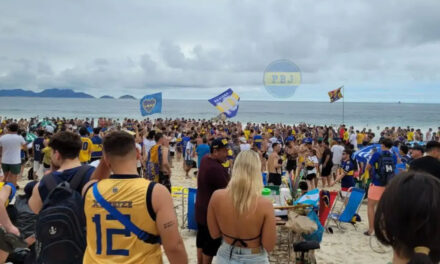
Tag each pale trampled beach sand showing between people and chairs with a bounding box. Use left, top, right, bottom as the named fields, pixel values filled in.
left=15, top=159, right=392, bottom=264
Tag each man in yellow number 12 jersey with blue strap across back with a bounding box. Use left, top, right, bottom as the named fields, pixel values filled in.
left=83, top=131, right=188, bottom=264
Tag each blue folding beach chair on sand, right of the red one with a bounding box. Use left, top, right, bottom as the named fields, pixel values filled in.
left=326, top=188, right=365, bottom=230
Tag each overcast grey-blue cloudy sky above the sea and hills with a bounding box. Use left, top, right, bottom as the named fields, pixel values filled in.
left=0, top=0, right=440, bottom=103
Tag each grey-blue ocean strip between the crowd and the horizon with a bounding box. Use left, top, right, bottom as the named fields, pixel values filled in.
left=0, top=97, right=440, bottom=131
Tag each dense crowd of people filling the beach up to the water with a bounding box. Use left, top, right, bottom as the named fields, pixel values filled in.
left=0, top=118, right=440, bottom=263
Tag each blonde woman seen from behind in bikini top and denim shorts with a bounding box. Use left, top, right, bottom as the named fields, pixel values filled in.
left=208, top=150, right=276, bottom=264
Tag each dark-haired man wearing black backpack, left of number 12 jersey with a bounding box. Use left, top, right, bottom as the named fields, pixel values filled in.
left=29, top=131, right=94, bottom=263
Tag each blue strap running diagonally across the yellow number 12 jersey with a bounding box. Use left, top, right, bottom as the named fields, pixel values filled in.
left=93, top=183, right=160, bottom=244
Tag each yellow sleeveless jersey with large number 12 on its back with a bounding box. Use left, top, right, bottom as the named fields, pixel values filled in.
left=83, top=175, right=162, bottom=264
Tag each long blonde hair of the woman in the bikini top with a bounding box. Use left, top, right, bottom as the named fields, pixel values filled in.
left=226, top=150, right=263, bottom=215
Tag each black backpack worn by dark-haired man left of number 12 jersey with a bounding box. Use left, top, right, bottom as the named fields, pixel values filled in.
left=35, top=166, right=90, bottom=264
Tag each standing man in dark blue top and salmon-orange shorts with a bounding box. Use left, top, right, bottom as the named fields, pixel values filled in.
left=364, top=138, right=397, bottom=236
